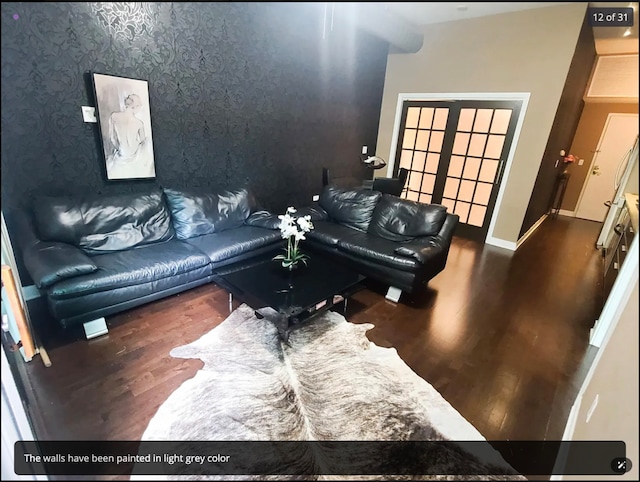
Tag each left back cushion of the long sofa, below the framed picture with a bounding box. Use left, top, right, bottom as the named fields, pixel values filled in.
left=33, top=189, right=174, bottom=254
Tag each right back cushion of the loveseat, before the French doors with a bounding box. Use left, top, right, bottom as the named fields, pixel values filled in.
left=368, top=194, right=447, bottom=242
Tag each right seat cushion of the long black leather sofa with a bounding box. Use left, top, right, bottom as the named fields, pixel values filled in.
left=187, top=226, right=282, bottom=263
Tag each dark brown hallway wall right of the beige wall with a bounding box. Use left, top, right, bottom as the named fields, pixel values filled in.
left=518, top=10, right=596, bottom=237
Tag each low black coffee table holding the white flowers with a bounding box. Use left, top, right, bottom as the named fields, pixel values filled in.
left=214, top=249, right=365, bottom=342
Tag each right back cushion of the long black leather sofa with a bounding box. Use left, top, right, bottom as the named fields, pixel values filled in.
left=164, top=188, right=256, bottom=239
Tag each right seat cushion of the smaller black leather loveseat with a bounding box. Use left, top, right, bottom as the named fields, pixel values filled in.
left=338, top=233, right=422, bottom=272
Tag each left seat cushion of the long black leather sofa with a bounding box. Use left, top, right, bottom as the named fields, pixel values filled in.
left=49, top=239, right=211, bottom=299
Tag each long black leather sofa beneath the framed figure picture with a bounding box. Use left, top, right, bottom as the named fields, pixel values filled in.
left=16, top=188, right=282, bottom=337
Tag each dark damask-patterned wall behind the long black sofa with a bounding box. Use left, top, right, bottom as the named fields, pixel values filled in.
left=1, top=2, right=388, bottom=282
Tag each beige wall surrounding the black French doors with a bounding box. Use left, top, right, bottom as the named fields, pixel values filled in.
left=376, top=2, right=587, bottom=243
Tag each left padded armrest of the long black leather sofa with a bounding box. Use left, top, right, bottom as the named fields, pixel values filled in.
left=24, top=241, right=98, bottom=288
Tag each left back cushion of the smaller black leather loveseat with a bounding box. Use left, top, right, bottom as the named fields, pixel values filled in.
left=319, top=185, right=382, bottom=232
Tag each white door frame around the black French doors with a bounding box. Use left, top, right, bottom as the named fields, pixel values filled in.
left=387, top=92, right=531, bottom=251
